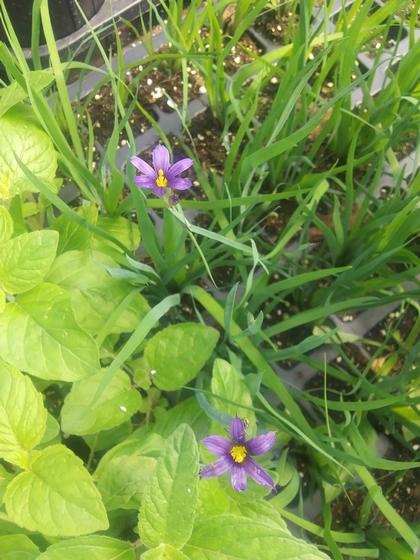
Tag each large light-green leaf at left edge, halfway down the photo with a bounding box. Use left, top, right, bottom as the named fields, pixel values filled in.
left=0, top=283, right=99, bottom=381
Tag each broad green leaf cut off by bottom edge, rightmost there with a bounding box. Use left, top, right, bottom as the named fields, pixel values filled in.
left=183, top=514, right=328, bottom=560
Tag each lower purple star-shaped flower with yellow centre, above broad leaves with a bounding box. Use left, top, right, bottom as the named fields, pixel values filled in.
left=200, top=417, right=276, bottom=492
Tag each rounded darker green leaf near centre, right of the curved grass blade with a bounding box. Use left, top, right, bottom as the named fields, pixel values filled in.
left=144, top=323, right=219, bottom=391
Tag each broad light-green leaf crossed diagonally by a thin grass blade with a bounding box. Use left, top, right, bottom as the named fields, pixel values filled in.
left=47, top=251, right=150, bottom=335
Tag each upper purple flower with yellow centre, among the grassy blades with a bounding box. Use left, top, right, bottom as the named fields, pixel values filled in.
left=130, top=144, right=193, bottom=196
